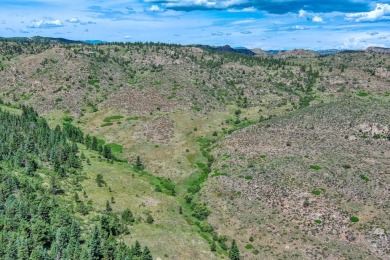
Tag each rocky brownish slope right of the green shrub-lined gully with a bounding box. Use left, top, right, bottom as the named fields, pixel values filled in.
left=203, top=97, right=390, bottom=259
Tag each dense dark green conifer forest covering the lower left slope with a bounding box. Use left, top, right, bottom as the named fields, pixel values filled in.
left=0, top=101, right=152, bottom=260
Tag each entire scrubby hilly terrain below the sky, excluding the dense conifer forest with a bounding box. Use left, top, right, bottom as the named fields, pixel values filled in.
left=0, top=41, right=390, bottom=259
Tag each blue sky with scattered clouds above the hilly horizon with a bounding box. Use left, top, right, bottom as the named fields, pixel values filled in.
left=0, top=0, right=390, bottom=50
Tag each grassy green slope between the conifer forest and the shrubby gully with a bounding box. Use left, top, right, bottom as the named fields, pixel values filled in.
left=79, top=145, right=216, bottom=259
